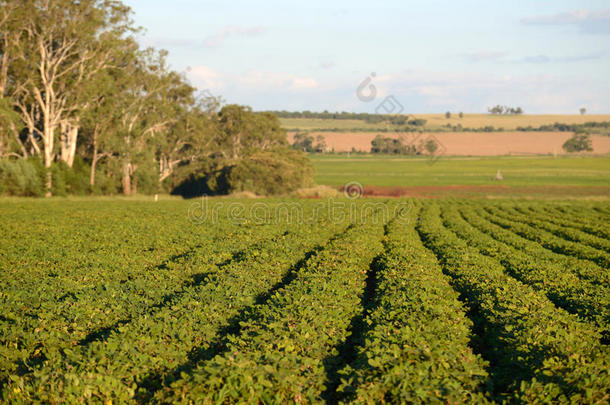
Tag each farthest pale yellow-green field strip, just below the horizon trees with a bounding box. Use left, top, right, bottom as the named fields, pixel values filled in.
left=280, top=112, right=610, bottom=131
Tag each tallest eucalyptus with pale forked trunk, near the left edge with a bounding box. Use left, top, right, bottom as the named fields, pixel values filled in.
left=13, top=0, right=131, bottom=195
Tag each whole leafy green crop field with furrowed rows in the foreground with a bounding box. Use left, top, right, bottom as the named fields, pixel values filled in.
left=0, top=198, right=610, bottom=404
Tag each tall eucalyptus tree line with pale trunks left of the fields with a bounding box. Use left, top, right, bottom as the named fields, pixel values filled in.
left=0, top=0, right=311, bottom=195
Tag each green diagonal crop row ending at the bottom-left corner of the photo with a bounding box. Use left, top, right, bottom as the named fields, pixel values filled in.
left=8, top=213, right=346, bottom=402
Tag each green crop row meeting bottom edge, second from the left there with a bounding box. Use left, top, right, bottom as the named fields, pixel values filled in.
left=160, top=213, right=383, bottom=403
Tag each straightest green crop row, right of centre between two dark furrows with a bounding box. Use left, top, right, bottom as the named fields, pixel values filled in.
left=339, top=207, right=487, bottom=404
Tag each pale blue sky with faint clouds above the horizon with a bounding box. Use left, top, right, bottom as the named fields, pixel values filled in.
left=125, top=0, right=610, bottom=114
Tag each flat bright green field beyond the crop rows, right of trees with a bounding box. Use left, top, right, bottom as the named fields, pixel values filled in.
left=311, top=154, right=610, bottom=196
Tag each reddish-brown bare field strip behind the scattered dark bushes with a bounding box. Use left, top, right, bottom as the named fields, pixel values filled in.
left=288, top=132, right=610, bottom=156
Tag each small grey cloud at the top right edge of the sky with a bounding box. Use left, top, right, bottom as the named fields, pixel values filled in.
left=521, top=9, right=610, bottom=34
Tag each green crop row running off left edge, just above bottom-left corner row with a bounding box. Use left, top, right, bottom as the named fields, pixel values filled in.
left=0, top=207, right=279, bottom=390
